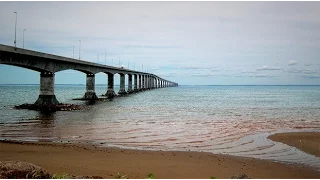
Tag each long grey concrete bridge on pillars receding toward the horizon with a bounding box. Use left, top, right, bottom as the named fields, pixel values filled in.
left=0, top=44, right=178, bottom=105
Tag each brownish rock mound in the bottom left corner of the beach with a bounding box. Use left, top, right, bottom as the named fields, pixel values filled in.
left=0, top=161, right=51, bottom=179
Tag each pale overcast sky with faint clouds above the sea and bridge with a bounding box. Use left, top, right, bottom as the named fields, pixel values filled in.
left=0, top=1, right=320, bottom=85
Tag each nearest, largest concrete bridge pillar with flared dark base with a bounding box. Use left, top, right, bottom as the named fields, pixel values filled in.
left=34, top=72, right=59, bottom=105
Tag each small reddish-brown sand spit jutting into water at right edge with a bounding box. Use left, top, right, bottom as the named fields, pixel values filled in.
left=268, top=132, right=320, bottom=157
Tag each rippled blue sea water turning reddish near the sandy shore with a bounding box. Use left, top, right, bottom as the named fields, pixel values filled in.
left=0, top=85, right=320, bottom=169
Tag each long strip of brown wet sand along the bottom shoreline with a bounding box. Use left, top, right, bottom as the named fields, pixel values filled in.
left=0, top=141, right=320, bottom=179
